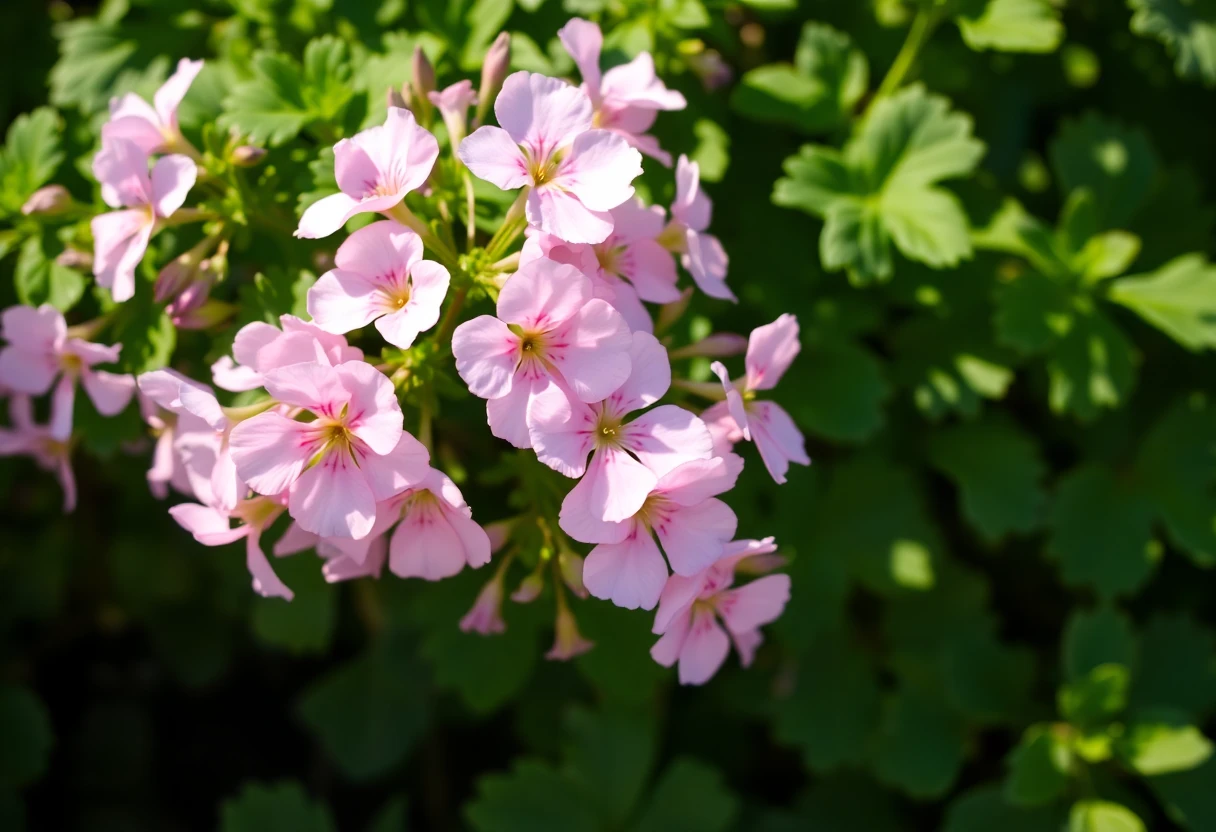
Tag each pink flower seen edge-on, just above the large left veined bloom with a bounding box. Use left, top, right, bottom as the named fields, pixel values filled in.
left=212, top=315, right=364, bottom=393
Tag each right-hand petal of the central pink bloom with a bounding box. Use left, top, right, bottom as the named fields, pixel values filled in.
left=548, top=299, right=632, bottom=401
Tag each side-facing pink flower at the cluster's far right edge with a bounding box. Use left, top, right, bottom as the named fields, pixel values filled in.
left=704, top=313, right=811, bottom=483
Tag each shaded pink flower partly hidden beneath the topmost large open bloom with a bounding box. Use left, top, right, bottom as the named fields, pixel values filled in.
left=519, top=198, right=680, bottom=332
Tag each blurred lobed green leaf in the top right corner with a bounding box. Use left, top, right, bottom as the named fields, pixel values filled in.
left=1128, top=0, right=1216, bottom=86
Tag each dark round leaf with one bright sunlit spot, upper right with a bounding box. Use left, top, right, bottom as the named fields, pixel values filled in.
left=1049, top=113, right=1158, bottom=229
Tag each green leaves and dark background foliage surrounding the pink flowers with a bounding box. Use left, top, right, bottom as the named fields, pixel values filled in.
left=0, top=0, right=1216, bottom=832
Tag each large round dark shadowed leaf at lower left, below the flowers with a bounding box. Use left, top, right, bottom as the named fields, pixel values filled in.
left=297, top=642, right=427, bottom=780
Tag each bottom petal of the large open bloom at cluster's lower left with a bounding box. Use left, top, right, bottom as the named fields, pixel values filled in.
left=288, top=449, right=376, bottom=540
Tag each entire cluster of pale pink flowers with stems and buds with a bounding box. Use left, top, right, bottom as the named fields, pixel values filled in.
left=9, top=19, right=810, bottom=684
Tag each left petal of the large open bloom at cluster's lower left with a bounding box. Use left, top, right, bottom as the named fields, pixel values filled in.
left=229, top=412, right=317, bottom=496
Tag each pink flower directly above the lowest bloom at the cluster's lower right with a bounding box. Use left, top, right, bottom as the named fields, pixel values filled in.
left=559, top=457, right=742, bottom=609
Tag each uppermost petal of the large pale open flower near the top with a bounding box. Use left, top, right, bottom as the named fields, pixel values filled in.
left=494, top=72, right=592, bottom=150
